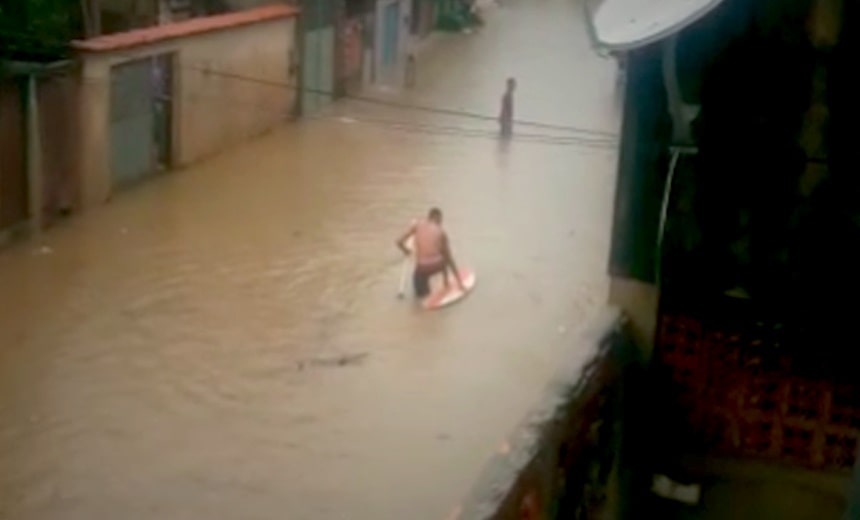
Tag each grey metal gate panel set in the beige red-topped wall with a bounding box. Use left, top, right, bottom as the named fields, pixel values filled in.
left=110, top=58, right=156, bottom=186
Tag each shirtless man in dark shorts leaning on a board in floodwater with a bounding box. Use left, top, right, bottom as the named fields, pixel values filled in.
left=397, top=208, right=465, bottom=298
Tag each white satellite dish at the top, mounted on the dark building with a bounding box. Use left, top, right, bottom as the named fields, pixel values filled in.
left=586, top=0, right=723, bottom=51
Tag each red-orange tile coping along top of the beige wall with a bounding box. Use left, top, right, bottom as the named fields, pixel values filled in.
left=72, top=4, right=299, bottom=52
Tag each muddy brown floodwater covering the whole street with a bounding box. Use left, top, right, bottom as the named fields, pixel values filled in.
left=0, top=0, right=618, bottom=520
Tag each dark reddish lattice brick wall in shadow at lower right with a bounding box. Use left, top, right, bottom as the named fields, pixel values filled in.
left=655, top=314, right=860, bottom=469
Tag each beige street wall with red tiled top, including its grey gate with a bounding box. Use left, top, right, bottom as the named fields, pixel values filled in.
left=74, top=5, right=299, bottom=206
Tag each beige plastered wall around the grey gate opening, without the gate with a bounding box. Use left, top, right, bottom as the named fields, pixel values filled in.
left=77, top=8, right=296, bottom=206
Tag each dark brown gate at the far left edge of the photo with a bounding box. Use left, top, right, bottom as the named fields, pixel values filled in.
left=0, top=81, right=28, bottom=230
